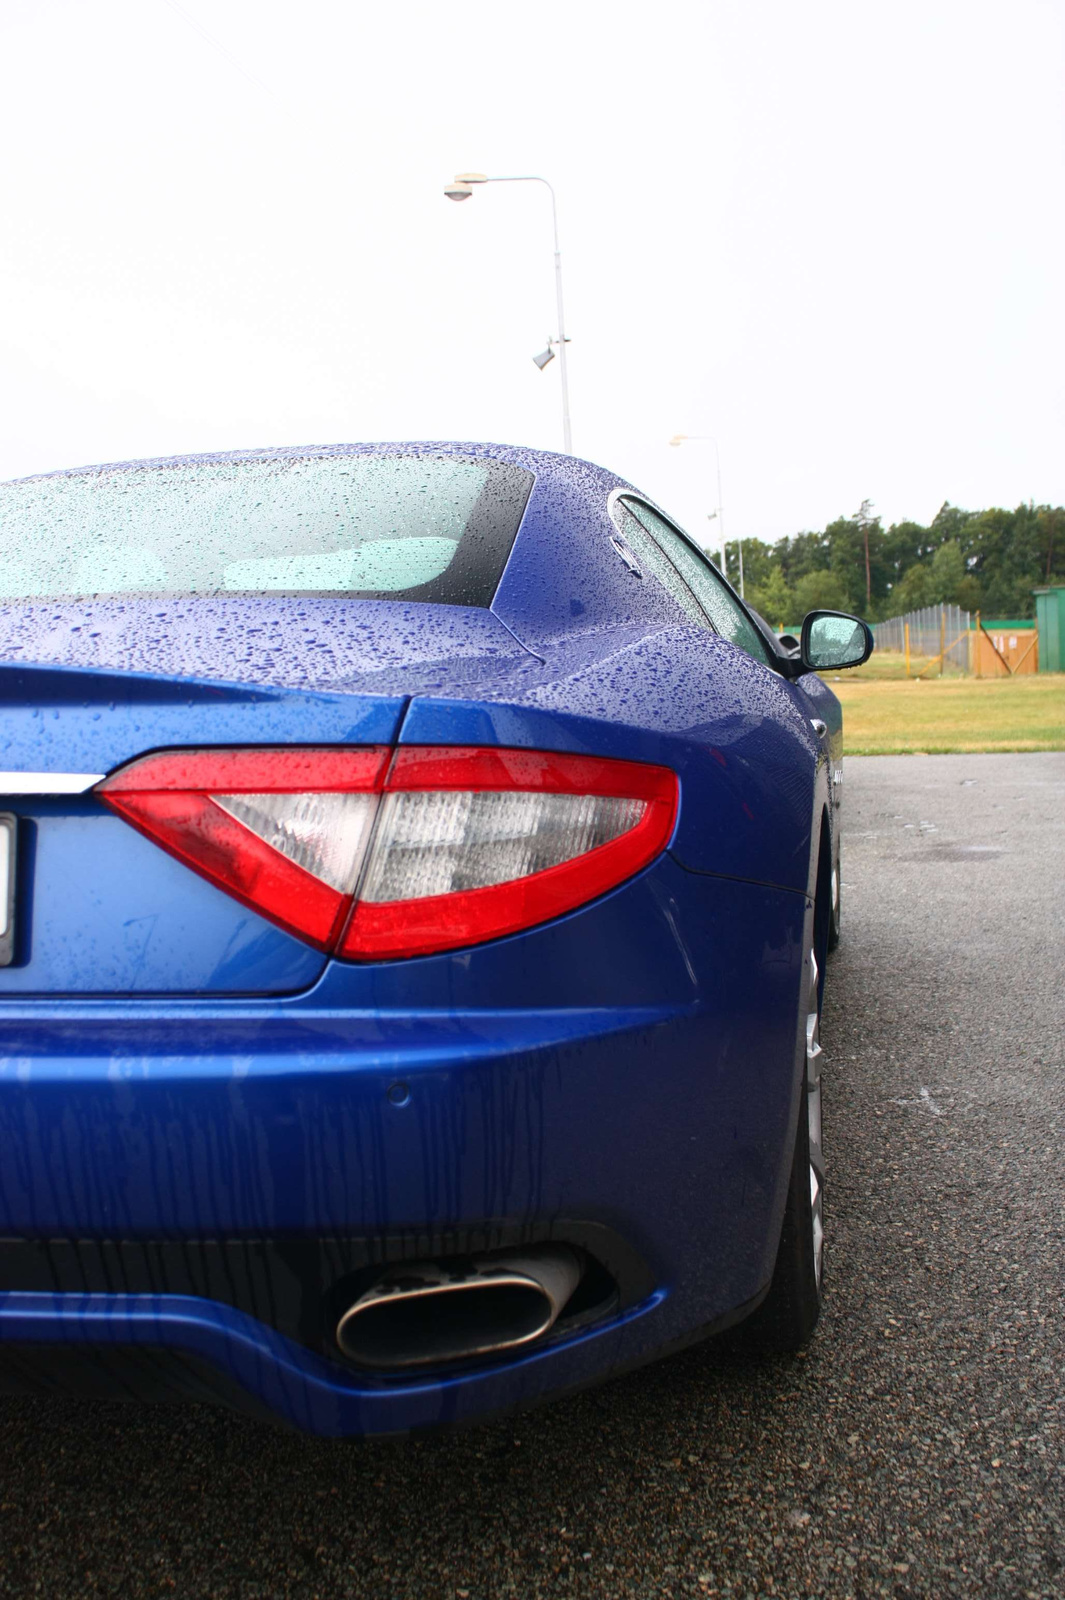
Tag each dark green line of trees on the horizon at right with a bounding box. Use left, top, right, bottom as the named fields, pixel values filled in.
left=726, top=501, right=1065, bottom=626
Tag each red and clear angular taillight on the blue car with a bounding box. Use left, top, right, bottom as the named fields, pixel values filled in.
left=96, top=747, right=676, bottom=960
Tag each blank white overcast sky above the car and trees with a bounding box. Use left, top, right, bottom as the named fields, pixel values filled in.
left=0, top=0, right=1065, bottom=542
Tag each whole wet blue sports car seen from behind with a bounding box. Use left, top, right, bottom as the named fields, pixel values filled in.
left=0, top=443, right=872, bottom=1434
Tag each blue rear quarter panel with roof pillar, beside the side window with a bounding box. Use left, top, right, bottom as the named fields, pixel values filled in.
left=476, top=462, right=835, bottom=891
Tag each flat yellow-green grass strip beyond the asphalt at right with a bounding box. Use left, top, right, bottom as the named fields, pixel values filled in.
left=825, top=667, right=1065, bottom=755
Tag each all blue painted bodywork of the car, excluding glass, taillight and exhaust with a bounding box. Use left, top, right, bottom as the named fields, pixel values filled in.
left=0, top=446, right=838, bottom=1432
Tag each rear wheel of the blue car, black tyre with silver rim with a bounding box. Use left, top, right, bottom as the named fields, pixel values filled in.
left=744, top=952, right=825, bottom=1354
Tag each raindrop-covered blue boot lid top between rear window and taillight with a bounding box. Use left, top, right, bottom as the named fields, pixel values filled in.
left=0, top=595, right=540, bottom=773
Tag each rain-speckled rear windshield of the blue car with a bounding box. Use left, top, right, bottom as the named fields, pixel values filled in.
left=0, top=454, right=533, bottom=606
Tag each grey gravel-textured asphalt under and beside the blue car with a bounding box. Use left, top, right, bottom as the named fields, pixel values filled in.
left=0, top=755, right=1065, bottom=1600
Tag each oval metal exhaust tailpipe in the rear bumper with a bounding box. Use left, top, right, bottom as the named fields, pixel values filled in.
left=336, top=1245, right=582, bottom=1370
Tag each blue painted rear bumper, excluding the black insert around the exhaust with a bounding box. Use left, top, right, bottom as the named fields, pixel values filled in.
left=0, top=866, right=806, bottom=1432
